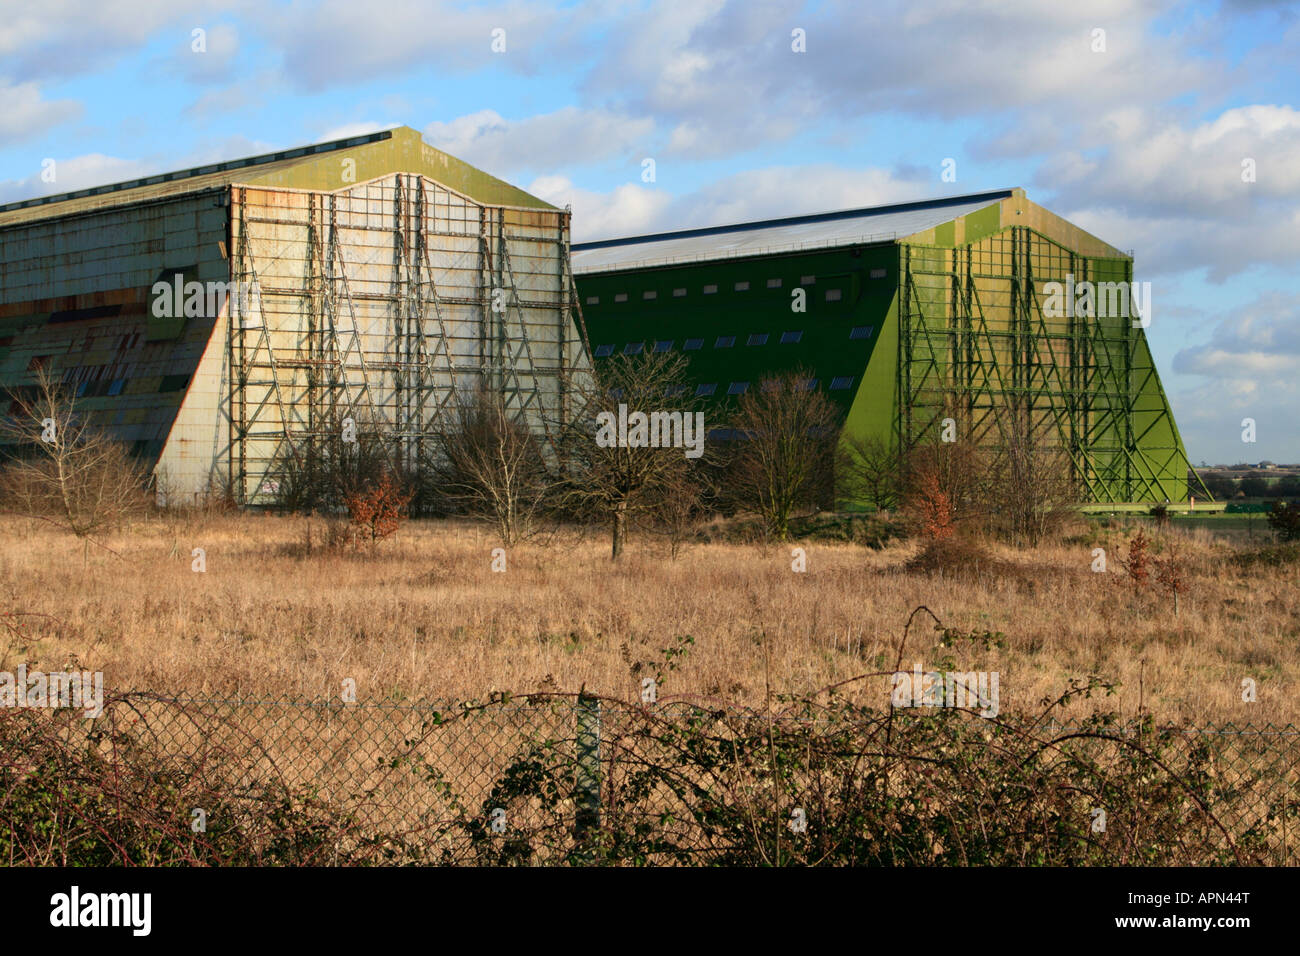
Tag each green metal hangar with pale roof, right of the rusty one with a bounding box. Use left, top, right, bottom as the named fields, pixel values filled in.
left=572, top=189, right=1188, bottom=502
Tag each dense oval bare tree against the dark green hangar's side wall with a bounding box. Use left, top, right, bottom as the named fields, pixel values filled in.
left=728, top=369, right=840, bottom=540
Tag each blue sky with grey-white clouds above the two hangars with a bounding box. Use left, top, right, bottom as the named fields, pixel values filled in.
left=0, top=0, right=1300, bottom=463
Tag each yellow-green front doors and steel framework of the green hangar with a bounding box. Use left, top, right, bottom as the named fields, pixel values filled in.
left=894, top=226, right=1209, bottom=502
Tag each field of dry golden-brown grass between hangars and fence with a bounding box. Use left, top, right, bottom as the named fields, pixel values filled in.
left=0, top=514, right=1300, bottom=724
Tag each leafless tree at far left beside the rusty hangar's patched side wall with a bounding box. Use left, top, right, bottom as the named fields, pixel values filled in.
left=0, top=368, right=148, bottom=548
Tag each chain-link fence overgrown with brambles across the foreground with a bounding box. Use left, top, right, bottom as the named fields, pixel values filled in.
left=0, top=693, right=1300, bottom=865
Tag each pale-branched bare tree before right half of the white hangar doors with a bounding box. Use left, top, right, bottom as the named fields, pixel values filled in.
left=428, top=388, right=556, bottom=548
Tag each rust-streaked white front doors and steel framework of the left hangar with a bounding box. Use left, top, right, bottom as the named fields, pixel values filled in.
left=228, top=174, right=585, bottom=503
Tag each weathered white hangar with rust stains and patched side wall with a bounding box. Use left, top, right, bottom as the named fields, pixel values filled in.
left=0, top=127, right=589, bottom=503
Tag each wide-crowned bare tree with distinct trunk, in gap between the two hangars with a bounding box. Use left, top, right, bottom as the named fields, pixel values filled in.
left=564, top=352, right=706, bottom=561
